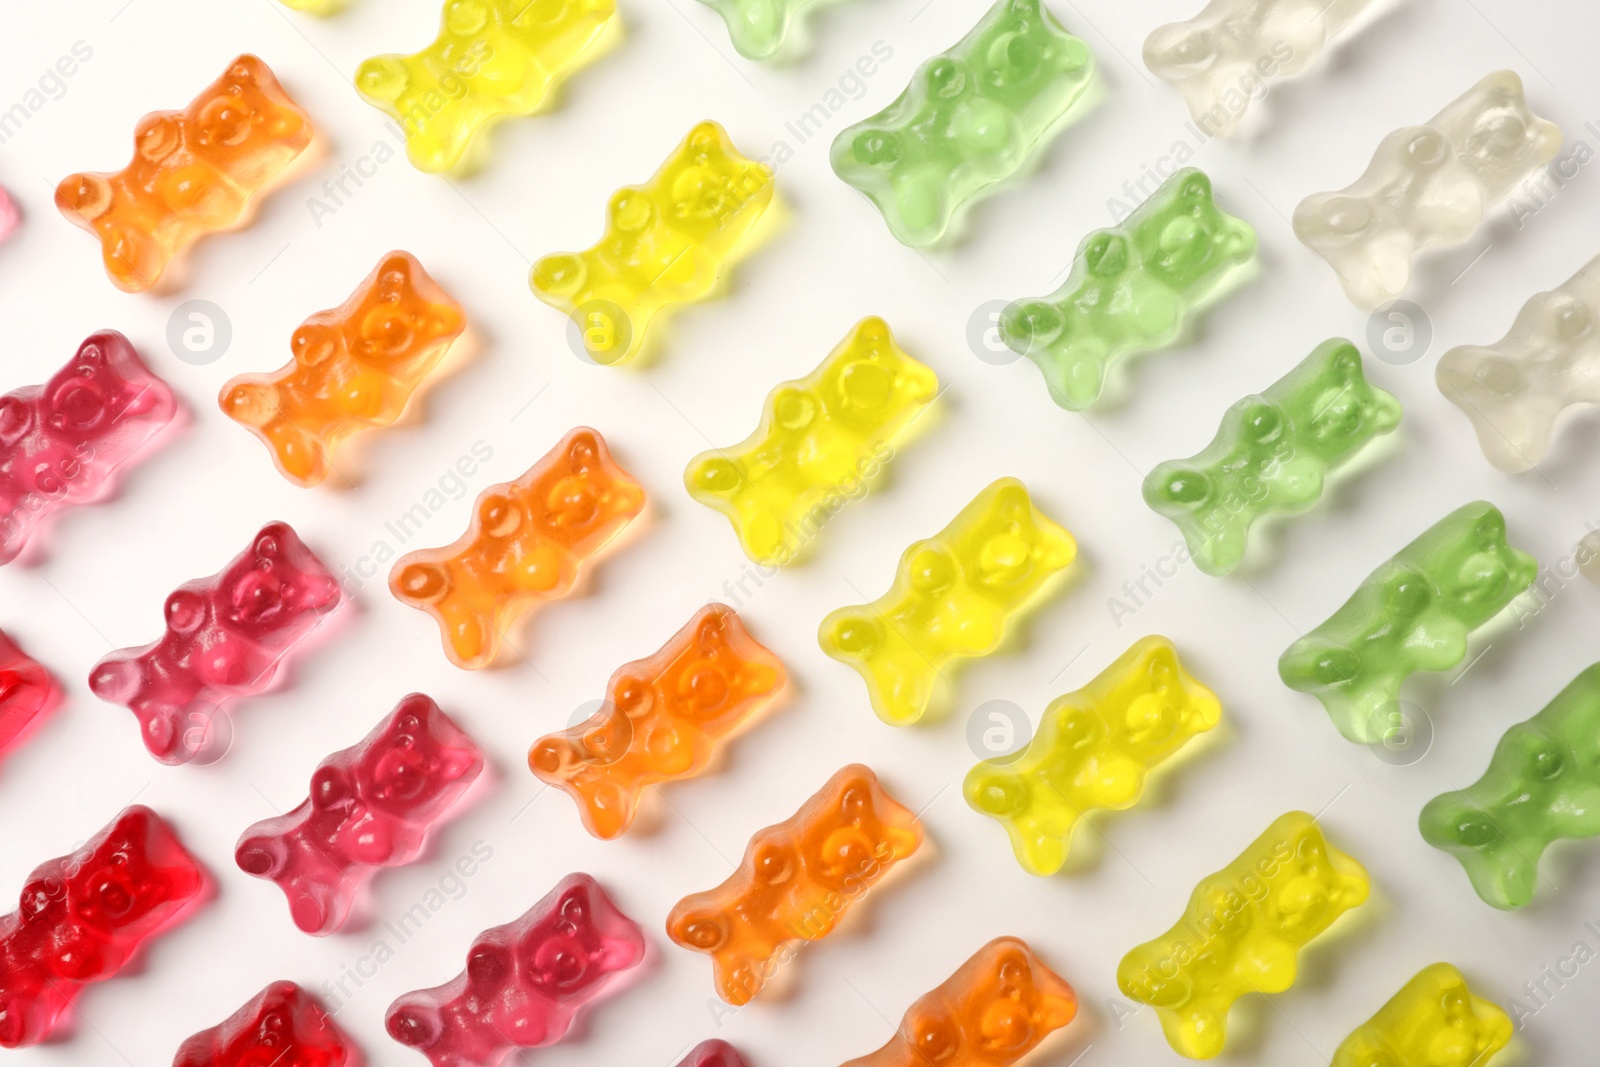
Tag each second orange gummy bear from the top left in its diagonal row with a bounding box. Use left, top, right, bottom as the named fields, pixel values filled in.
left=219, top=251, right=467, bottom=486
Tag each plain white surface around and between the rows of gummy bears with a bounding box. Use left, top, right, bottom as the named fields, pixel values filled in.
left=0, top=0, right=1600, bottom=1067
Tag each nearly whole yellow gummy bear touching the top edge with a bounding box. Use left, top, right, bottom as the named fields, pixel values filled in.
left=355, top=0, right=616, bottom=174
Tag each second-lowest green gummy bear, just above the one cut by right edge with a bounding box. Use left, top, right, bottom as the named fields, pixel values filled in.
left=1278, top=501, right=1539, bottom=744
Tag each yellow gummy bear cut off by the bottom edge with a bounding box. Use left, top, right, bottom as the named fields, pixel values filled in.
left=1333, top=963, right=1512, bottom=1067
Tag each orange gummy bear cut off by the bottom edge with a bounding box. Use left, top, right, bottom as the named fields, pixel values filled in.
left=845, top=937, right=1078, bottom=1067
